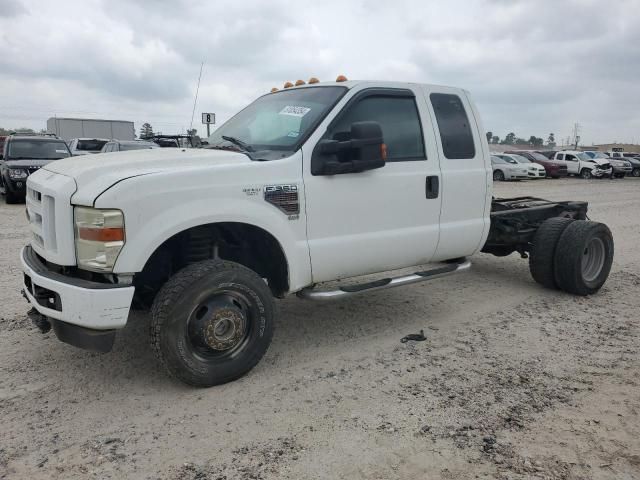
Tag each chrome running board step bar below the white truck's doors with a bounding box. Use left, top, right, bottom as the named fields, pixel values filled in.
left=297, top=258, right=471, bottom=301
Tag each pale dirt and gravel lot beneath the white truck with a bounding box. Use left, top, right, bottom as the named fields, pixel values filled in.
left=0, top=179, right=640, bottom=480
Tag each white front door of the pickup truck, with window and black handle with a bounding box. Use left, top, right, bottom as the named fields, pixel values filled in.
left=303, top=84, right=441, bottom=282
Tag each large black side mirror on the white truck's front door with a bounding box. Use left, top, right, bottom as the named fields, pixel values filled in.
left=311, top=122, right=387, bottom=175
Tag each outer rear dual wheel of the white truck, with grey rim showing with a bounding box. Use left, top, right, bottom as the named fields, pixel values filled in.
left=555, top=220, right=614, bottom=296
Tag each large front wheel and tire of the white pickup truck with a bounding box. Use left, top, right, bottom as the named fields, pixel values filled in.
left=151, top=260, right=275, bottom=387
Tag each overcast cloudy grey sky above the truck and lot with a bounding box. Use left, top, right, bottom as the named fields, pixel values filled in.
left=0, top=0, right=640, bottom=144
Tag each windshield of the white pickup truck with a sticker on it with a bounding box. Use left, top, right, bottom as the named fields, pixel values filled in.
left=207, top=87, right=346, bottom=159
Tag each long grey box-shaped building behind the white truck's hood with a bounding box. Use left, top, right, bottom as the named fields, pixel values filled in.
left=47, top=117, right=135, bottom=141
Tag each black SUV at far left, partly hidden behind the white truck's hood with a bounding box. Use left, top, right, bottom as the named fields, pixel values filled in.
left=0, top=134, right=71, bottom=203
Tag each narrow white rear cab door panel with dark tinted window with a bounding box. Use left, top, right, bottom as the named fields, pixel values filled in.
left=424, top=86, right=493, bottom=260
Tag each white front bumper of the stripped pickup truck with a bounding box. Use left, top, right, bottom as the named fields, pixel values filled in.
left=20, top=246, right=135, bottom=332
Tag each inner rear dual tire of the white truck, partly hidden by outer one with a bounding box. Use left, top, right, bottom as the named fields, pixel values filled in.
left=529, top=217, right=574, bottom=288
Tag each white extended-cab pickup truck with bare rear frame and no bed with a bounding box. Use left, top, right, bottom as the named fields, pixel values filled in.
left=21, top=81, right=613, bottom=386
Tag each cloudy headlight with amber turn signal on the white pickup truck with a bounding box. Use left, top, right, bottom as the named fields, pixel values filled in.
left=74, top=207, right=125, bottom=272
